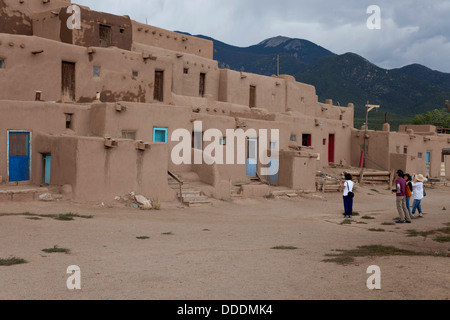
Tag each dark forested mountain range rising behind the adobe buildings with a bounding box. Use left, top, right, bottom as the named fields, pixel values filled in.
left=178, top=35, right=450, bottom=130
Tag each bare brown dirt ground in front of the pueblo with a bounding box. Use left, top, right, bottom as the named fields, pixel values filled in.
left=0, top=182, right=450, bottom=300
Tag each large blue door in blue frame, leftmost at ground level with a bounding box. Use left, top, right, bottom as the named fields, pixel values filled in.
left=8, top=131, right=30, bottom=182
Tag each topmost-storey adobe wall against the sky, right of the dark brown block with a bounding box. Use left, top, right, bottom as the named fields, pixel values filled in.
left=132, top=21, right=214, bottom=60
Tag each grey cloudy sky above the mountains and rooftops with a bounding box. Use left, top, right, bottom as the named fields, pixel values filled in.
left=72, top=0, right=450, bottom=73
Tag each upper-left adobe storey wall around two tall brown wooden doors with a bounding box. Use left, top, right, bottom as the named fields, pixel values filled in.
left=0, top=34, right=172, bottom=103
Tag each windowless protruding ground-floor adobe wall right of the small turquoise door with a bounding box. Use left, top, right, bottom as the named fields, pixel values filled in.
left=73, top=137, right=176, bottom=201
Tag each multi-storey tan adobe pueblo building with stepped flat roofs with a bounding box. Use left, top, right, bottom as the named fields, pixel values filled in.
left=0, top=0, right=450, bottom=201
